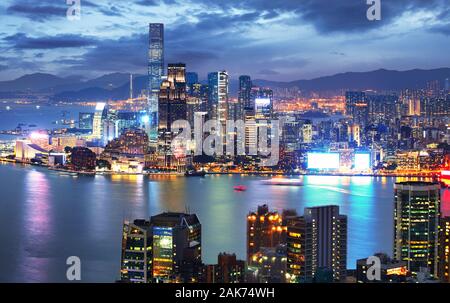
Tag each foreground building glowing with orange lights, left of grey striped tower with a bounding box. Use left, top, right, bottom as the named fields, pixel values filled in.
left=247, top=204, right=286, bottom=264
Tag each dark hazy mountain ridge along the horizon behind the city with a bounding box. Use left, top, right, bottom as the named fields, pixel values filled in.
left=0, top=68, right=450, bottom=101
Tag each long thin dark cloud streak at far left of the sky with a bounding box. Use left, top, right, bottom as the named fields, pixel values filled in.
left=3, top=34, right=95, bottom=50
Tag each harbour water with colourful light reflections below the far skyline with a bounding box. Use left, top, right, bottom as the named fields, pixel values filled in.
left=0, top=165, right=450, bottom=282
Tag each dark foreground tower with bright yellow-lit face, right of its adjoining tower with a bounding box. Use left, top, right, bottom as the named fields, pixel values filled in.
left=150, top=213, right=202, bottom=282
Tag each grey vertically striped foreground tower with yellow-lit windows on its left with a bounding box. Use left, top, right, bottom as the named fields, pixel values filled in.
left=287, top=206, right=347, bottom=282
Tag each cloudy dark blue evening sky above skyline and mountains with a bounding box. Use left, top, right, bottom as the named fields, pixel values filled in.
left=0, top=0, right=450, bottom=80
